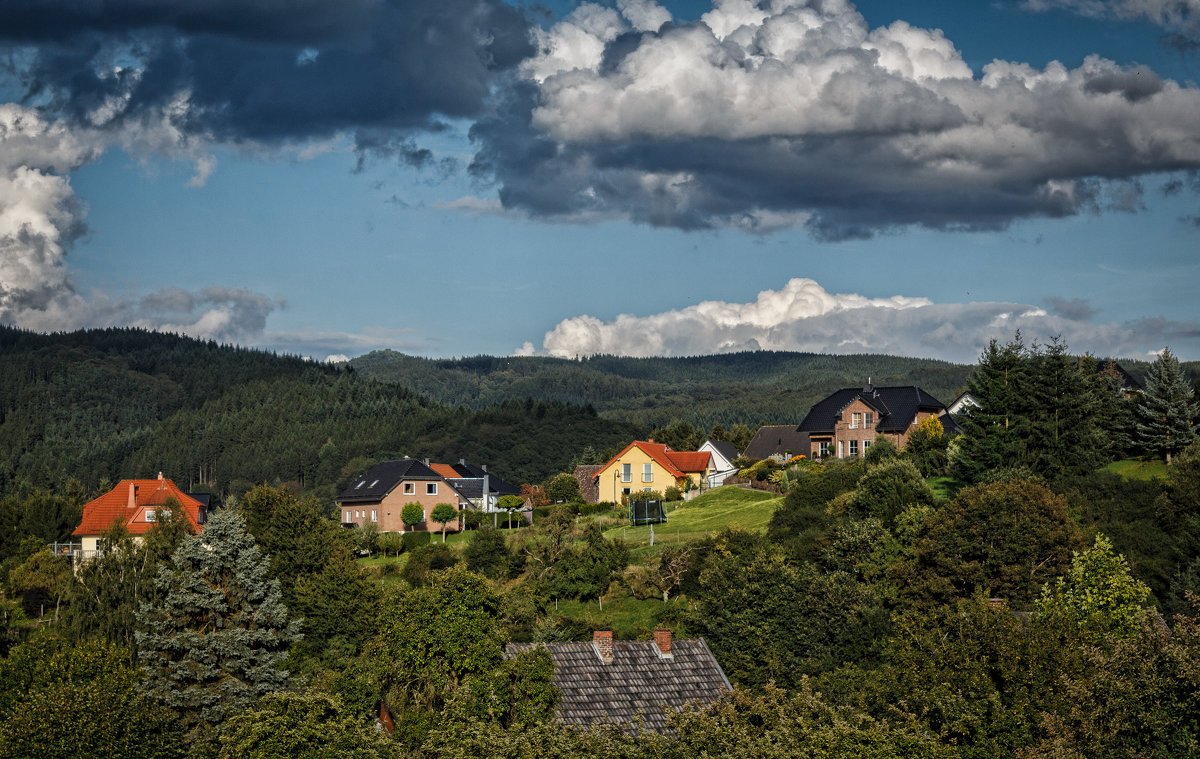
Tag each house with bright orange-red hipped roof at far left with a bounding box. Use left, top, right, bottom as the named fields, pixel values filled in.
left=71, top=472, right=208, bottom=558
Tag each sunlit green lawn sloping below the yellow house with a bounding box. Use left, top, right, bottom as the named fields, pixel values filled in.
left=605, top=485, right=784, bottom=552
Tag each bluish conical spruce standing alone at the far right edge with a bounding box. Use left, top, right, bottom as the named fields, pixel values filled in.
left=1138, top=348, right=1196, bottom=464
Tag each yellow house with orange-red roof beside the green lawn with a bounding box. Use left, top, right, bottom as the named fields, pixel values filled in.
left=595, top=440, right=713, bottom=503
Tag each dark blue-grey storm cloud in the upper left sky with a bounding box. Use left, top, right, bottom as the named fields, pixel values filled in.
left=0, top=0, right=532, bottom=142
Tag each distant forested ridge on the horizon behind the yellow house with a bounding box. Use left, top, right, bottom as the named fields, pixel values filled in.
left=352, top=351, right=970, bottom=429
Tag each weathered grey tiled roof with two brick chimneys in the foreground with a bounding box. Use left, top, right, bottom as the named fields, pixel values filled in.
left=506, top=638, right=732, bottom=733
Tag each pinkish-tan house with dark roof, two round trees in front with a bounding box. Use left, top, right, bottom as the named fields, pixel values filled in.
left=335, top=459, right=473, bottom=532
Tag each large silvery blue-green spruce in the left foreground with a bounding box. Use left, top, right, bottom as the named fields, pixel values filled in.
left=137, top=509, right=300, bottom=737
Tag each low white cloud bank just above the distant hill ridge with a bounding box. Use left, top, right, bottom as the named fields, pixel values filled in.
left=516, top=279, right=1200, bottom=363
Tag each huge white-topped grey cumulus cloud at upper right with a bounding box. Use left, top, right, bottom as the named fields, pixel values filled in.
left=472, top=0, right=1200, bottom=239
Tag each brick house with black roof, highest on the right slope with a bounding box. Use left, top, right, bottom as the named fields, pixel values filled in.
left=797, top=383, right=946, bottom=459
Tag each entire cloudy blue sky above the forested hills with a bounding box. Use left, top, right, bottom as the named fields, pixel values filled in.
left=0, top=0, right=1200, bottom=363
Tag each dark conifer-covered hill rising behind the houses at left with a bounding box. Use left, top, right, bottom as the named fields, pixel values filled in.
left=0, top=327, right=642, bottom=497
